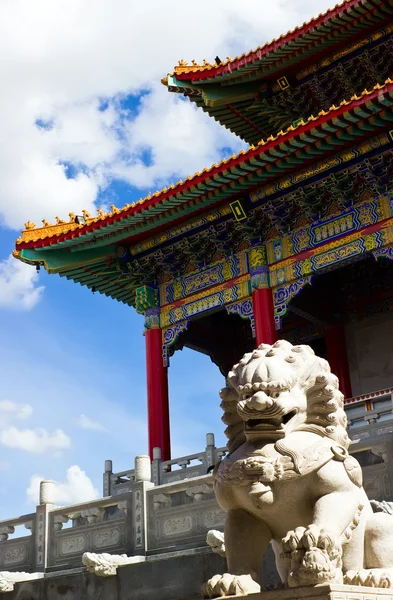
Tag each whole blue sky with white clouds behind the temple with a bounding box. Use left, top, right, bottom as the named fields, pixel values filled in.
left=0, top=0, right=329, bottom=520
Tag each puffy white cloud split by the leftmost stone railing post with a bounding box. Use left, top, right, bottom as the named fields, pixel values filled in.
left=26, top=465, right=99, bottom=506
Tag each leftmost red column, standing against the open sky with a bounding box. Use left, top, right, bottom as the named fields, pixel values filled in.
left=145, top=328, right=171, bottom=460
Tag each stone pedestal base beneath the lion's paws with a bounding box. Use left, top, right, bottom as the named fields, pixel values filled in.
left=222, top=584, right=393, bottom=600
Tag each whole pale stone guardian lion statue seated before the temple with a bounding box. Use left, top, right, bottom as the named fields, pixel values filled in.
left=203, top=340, right=393, bottom=598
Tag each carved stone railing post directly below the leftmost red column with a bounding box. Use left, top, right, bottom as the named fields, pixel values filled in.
left=132, top=456, right=154, bottom=555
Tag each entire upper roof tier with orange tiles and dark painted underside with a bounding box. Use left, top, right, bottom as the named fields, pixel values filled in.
left=163, top=0, right=393, bottom=144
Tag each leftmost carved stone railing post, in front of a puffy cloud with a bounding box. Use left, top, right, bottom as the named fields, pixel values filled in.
left=34, top=481, right=56, bottom=572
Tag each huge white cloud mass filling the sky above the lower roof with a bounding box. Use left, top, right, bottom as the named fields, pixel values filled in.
left=0, top=0, right=330, bottom=228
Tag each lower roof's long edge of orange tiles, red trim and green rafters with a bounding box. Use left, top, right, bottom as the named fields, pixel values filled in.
left=16, top=79, right=393, bottom=254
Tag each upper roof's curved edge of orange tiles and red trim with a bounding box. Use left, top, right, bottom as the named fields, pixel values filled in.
left=163, top=0, right=393, bottom=84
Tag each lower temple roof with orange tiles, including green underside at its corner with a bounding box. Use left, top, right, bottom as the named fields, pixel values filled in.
left=15, top=79, right=393, bottom=304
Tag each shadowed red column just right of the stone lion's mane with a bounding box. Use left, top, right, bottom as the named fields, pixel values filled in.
left=325, top=325, right=352, bottom=398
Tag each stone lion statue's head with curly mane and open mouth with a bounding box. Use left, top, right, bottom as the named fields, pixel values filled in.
left=221, top=340, right=349, bottom=452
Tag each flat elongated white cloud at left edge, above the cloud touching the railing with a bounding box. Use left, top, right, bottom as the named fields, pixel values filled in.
left=0, top=427, right=71, bottom=454
